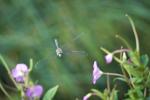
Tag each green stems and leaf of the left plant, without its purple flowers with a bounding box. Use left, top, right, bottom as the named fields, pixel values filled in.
left=0, top=55, right=59, bottom=100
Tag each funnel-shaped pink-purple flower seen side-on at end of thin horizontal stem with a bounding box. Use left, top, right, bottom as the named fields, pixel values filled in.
left=93, top=61, right=103, bottom=84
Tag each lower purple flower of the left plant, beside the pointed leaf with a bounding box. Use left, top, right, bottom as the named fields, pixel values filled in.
left=26, top=85, right=43, bottom=99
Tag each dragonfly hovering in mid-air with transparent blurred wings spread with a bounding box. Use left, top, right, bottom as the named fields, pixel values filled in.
left=36, top=33, right=88, bottom=68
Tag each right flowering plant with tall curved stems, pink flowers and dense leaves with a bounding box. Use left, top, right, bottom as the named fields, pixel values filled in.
left=83, top=15, right=150, bottom=100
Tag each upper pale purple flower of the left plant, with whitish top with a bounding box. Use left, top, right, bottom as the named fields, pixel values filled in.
left=11, top=64, right=29, bottom=83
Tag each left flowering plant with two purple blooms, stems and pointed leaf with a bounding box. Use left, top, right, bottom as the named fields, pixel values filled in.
left=0, top=55, right=58, bottom=100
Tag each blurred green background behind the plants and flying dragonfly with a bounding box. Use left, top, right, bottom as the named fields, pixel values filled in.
left=0, top=0, right=150, bottom=100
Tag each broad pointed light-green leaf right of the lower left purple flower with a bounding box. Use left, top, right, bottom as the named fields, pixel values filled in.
left=43, top=85, right=59, bottom=100
